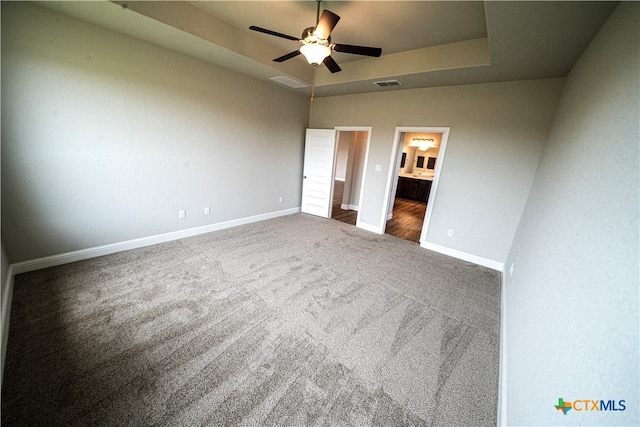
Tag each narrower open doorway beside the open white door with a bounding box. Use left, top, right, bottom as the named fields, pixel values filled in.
left=331, top=127, right=370, bottom=225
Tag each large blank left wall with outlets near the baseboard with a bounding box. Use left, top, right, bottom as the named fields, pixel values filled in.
left=2, top=2, right=309, bottom=262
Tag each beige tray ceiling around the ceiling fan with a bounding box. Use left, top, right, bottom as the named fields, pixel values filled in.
left=38, top=1, right=617, bottom=96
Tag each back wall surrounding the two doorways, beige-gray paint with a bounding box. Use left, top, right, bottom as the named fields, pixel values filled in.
left=310, top=79, right=563, bottom=263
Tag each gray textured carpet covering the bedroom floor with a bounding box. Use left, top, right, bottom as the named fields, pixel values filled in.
left=2, top=214, right=500, bottom=426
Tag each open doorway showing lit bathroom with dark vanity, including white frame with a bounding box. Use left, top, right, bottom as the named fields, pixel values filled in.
left=385, top=127, right=449, bottom=244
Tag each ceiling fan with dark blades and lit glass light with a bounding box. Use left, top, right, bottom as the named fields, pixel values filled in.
left=249, top=0, right=382, bottom=73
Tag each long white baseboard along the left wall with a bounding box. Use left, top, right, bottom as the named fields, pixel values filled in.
left=11, top=207, right=300, bottom=274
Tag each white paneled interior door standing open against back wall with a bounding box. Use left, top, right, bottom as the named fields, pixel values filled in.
left=300, top=129, right=336, bottom=218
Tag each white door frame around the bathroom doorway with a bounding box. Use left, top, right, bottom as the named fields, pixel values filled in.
left=381, top=126, right=451, bottom=247
